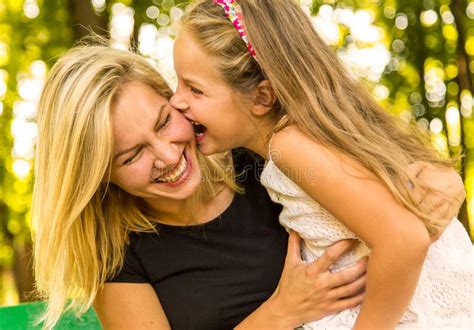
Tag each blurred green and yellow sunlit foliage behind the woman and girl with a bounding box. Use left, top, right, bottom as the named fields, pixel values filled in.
left=0, top=0, right=474, bottom=305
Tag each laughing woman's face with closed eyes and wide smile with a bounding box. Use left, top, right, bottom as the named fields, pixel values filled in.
left=111, top=81, right=201, bottom=203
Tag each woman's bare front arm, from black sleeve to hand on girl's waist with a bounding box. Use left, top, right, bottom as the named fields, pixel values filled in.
left=94, top=233, right=367, bottom=330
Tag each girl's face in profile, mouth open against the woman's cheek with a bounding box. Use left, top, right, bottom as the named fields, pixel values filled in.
left=170, top=31, right=255, bottom=155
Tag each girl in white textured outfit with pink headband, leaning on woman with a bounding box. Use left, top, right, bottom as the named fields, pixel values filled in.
left=172, top=0, right=473, bottom=329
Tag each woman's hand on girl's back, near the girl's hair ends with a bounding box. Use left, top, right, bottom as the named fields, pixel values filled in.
left=402, top=162, right=466, bottom=241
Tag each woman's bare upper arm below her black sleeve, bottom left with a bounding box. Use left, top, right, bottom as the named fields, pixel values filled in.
left=94, top=283, right=171, bottom=330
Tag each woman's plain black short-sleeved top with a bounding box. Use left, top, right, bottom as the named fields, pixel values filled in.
left=112, top=151, right=288, bottom=329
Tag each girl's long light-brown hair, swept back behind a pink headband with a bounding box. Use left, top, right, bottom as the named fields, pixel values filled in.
left=180, top=0, right=453, bottom=233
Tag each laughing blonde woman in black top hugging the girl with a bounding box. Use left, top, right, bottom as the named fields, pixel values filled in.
left=33, top=42, right=462, bottom=329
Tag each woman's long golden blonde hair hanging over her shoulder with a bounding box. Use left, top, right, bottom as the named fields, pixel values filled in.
left=32, top=45, right=236, bottom=328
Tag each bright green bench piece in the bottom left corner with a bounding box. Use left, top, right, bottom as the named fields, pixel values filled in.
left=0, top=302, right=102, bottom=330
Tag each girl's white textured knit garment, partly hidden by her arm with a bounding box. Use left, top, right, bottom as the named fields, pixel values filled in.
left=261, top=159, right=474, bottom=329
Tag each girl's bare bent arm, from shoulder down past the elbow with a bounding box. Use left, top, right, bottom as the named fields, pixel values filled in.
left=272, top=127, right=430, bottom=329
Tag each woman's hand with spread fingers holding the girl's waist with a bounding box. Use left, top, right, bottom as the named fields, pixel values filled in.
left=267, top=232, right=367, bottom=327
